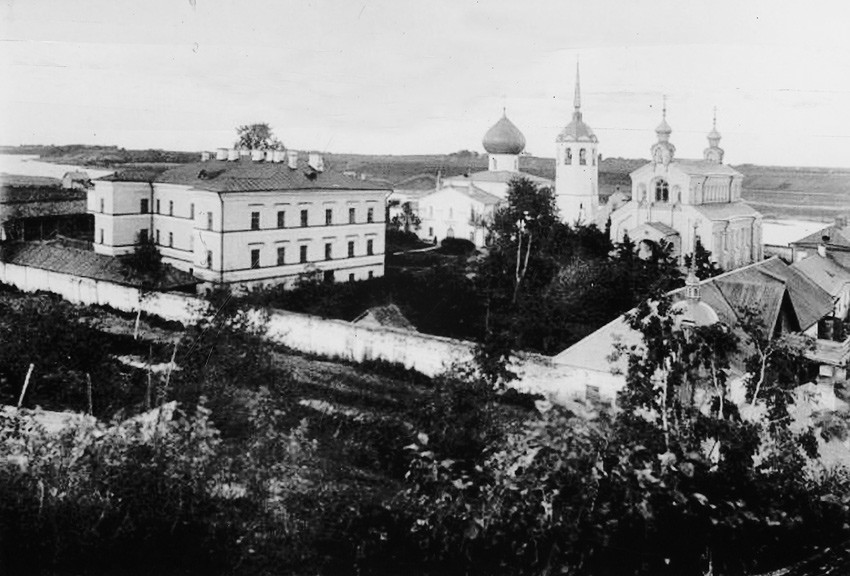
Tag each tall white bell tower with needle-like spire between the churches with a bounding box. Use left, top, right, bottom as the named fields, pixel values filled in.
left=555, top=63, right=599, bottom=224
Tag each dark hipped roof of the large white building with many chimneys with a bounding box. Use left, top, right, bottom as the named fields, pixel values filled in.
left=100, top=155, right=392, bottom=192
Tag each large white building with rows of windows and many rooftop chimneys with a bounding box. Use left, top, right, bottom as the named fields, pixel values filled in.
left=88, top=149, right=390, bottom=288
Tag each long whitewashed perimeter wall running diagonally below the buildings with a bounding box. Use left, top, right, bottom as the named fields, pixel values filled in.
left=0, top=262, right=596, bottom=401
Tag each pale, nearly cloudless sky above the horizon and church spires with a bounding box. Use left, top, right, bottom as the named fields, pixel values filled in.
left=0, top=0, right=850, bottom=167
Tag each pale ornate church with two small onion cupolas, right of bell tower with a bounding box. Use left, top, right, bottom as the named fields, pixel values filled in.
left=611, top=104, right=762, bottom=270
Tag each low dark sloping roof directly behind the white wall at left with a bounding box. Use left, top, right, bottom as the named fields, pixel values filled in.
left=0, top=242, right=198, bottom=290
